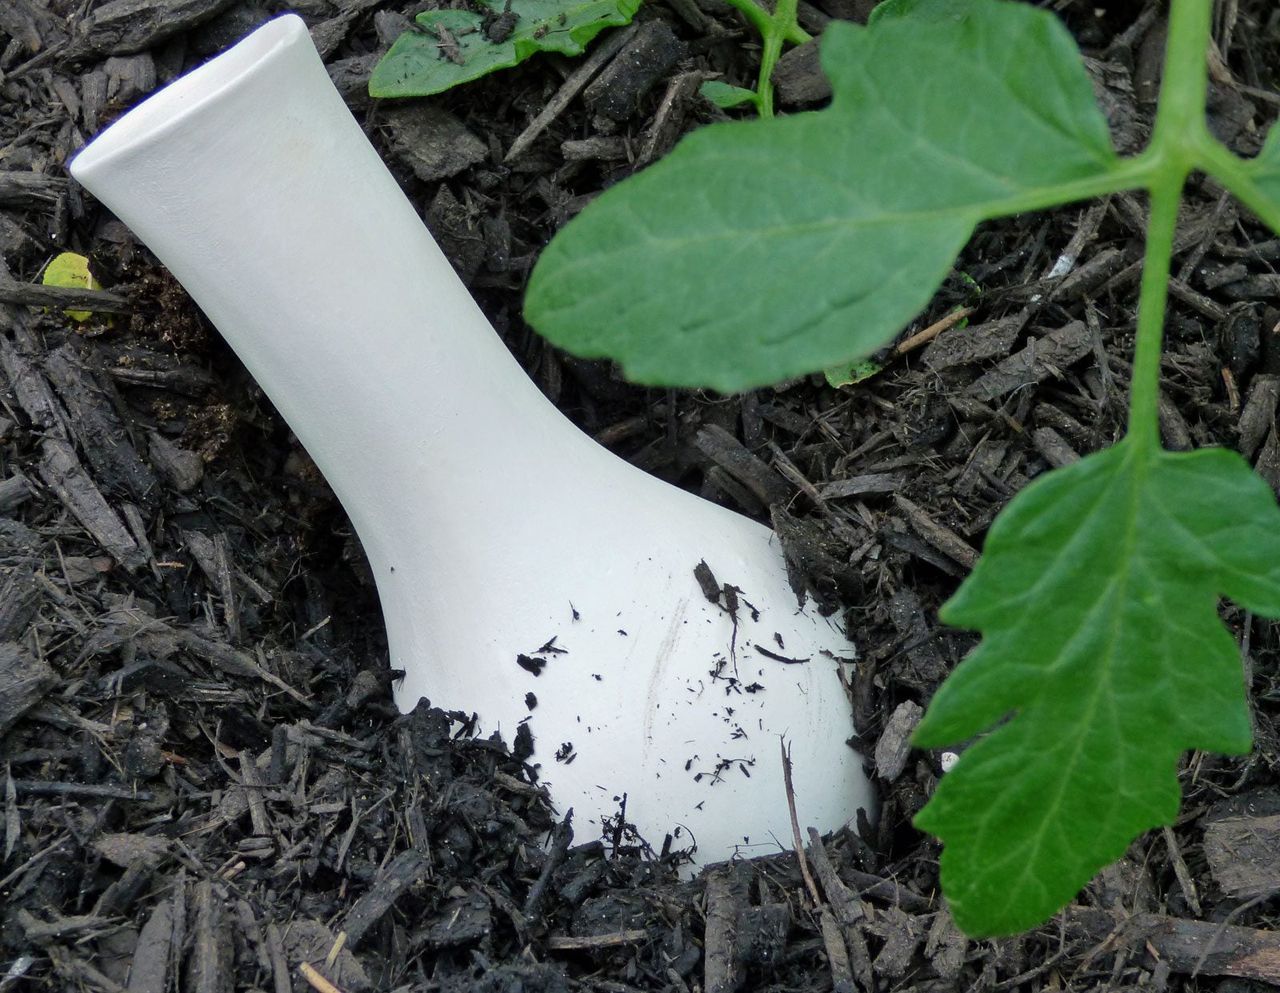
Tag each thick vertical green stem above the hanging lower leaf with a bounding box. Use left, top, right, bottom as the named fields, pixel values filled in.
left=1129, top=0, right=1212, bottom=450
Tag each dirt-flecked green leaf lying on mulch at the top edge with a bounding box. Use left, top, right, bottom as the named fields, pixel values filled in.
left=369, top=0, right=640, bottom=97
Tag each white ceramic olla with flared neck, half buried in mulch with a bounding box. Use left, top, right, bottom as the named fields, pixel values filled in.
left=70, top=15, right=872, bottom=862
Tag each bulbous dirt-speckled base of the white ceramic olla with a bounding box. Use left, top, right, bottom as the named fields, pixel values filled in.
left=375, top=468, right=873, bottom=864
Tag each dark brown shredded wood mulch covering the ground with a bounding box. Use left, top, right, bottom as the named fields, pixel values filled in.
left=0, top=0, right=1280, bottom=993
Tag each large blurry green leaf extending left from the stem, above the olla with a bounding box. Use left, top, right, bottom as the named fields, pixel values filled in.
left=525, top=0, right=1128, bottom=392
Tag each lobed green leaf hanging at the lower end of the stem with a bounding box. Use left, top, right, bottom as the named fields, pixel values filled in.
left=915, top=439, right=1280, bottom=935
